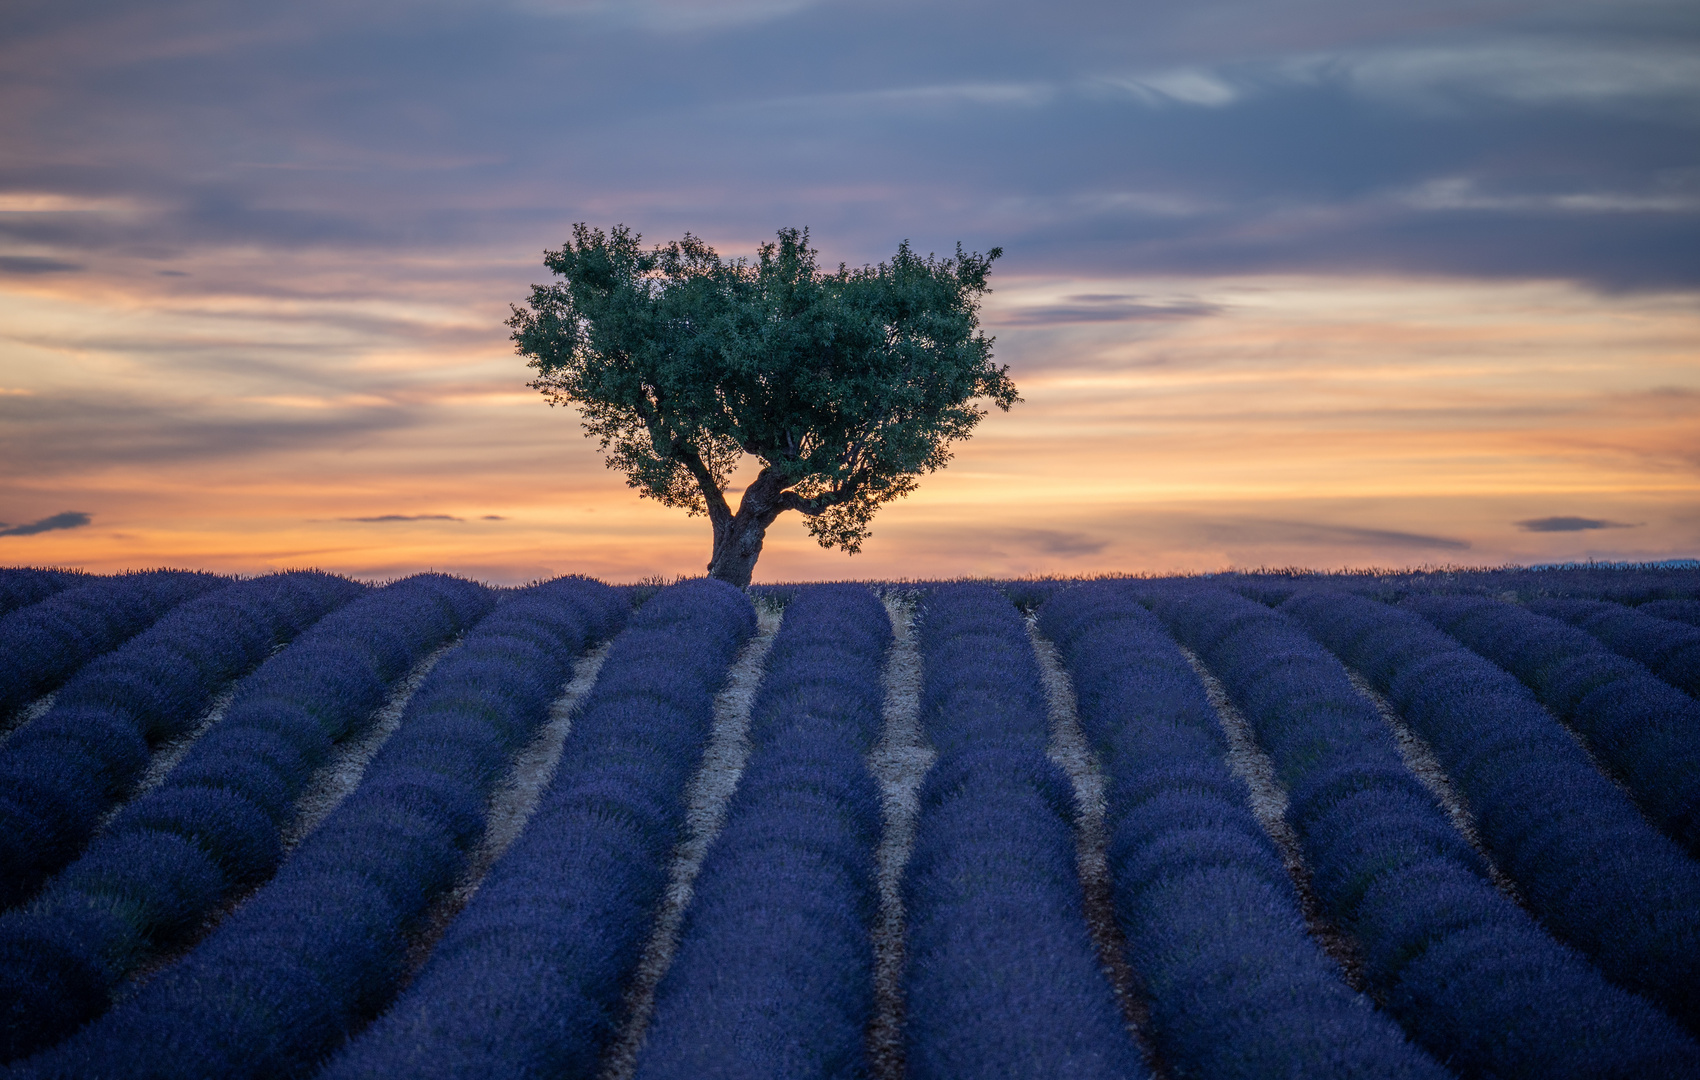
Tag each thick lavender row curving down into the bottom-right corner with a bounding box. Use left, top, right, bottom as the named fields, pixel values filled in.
left=1158, top=590, right=1700, bottom=1080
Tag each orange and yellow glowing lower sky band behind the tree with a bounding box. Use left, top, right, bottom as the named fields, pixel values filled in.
left=0, top=260, right=1700, bottom=583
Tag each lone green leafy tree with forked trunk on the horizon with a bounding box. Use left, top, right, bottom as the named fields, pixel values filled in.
left=508, top=225, right=1020, bottom=585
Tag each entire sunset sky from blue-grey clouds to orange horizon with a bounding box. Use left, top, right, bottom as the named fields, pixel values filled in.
left=0, top=0, right=1700, bottom=583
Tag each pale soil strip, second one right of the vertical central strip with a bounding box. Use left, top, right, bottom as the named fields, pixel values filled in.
left=1176, top=643, right=1365, bottom=993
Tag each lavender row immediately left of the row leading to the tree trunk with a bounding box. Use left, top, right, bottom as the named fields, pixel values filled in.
left=16, top=578, right=627, bottom=1080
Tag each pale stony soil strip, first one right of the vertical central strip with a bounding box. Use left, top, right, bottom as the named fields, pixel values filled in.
left=1027, top=616, right=1166, bottom=1077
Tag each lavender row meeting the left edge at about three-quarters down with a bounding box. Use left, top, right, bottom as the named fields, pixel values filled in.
left=0, top=573, right=362, bottom=907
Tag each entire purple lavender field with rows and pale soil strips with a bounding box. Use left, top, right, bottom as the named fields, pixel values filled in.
left=0, top=568, right=1700, bottom=1080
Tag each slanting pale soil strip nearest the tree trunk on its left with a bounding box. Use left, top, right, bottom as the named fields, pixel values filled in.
left=401, top=639, right=612, bottom=986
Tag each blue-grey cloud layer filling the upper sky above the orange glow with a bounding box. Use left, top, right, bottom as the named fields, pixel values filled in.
left=0, top=0, right=1700, bottom=290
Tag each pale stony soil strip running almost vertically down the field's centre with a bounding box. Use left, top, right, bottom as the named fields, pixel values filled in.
left=867, top=592, right=938, bottom=1080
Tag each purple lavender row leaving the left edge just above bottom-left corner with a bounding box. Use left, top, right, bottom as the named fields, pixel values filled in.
left=0, top=575, right=493, bottom=1060
